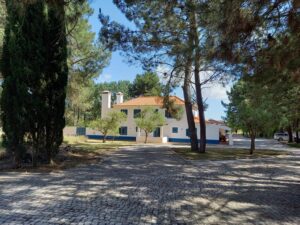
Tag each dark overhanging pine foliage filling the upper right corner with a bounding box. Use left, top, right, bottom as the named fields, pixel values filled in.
left=210, top=0, right=300, bottom=144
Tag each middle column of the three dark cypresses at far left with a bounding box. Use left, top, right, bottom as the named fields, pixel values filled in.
left=21, top=1, right=46, bottom=166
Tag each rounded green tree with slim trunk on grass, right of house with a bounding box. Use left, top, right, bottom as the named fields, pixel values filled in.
left=223, top=80, right=276, bottom=152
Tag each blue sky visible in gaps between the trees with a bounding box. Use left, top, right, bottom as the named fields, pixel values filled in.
left=89, top=0, right=227, bottom=119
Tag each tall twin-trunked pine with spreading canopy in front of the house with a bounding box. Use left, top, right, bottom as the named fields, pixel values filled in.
left=99, top=0, right=211, bottom=152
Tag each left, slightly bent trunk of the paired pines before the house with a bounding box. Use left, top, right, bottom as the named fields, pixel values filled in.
left=182, top=60, right=198, bottom=151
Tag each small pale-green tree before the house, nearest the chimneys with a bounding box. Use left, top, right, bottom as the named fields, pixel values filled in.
left=90, top=111, right=127, bottom=142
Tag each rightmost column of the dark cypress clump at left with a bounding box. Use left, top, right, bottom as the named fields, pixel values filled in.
left=45, top=1, right=68, bottom=162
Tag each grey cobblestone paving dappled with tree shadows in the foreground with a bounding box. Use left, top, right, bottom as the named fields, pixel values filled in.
left=0, top=147, right=300, bottom=225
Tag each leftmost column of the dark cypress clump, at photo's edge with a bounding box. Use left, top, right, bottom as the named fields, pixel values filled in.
left=1, top=0, right=28, bottom=166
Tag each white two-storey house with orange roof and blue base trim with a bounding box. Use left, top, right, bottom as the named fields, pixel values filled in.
left=87, top=91, right=232, bottom=144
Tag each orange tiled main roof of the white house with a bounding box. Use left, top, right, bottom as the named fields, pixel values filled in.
left=114, top=96, right=184, bottom=107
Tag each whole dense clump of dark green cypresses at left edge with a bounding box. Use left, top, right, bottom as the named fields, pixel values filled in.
left=1, top=1, right=68, bottom=165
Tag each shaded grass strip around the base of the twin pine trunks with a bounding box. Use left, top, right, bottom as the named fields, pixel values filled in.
left=173, top=148, right=289, bottom=160
